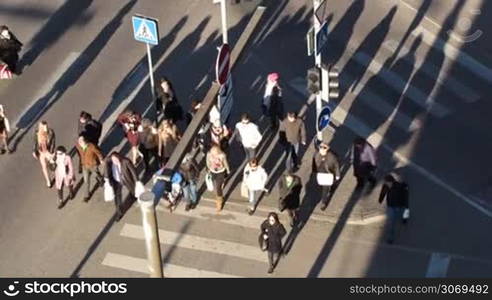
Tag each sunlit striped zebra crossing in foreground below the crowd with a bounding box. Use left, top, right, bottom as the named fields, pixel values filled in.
left=101, top=199, right=288, bottom=278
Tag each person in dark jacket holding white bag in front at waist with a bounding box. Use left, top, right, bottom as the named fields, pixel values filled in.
left=312, top=142, right=340, bottom=210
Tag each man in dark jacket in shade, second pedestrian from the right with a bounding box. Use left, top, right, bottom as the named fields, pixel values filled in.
left=351, top=137, right=376, bottom=188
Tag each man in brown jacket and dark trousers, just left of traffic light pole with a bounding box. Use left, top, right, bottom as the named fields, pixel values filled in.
left=279, top=111, right=306, bottom=171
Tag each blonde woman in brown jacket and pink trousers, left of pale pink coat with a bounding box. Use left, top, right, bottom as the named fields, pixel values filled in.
left=32, top=121, right=55, bottom=188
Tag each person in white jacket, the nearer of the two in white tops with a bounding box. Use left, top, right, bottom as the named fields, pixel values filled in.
left=243, top=158, right=268, bottom=215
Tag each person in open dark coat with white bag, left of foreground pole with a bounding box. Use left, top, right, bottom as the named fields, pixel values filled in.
left=104, top=151, right=138, bottom=221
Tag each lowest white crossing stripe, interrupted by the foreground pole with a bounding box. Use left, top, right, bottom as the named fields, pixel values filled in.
left=102, top=252, right=241, bottom=278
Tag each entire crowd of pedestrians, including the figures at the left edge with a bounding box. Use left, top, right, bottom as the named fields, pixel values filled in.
left=0, top=26, right=409, bottom=273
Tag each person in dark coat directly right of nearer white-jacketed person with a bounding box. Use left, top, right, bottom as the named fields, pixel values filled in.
left=278, top=172, right=302, bottom=227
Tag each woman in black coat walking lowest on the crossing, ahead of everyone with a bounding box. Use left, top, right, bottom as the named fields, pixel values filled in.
left=260, top=212, right=287, bottom=273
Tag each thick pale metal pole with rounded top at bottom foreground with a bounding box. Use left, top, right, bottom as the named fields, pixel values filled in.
left=138, top=191, right=164, bottom=278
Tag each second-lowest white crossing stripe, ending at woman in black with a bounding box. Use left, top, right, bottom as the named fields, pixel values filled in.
left=120, top=224, right=268, bottom=262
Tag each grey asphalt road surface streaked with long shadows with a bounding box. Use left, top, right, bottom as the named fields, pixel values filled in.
left=0, top=0, right=492, bottom=277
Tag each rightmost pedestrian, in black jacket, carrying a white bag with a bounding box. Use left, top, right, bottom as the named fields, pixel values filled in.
left=379, top=174, right=408, bottom=244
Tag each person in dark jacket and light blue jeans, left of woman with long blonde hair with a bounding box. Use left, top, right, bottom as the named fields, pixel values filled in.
left=180, top=154, right=200, bottom=211
